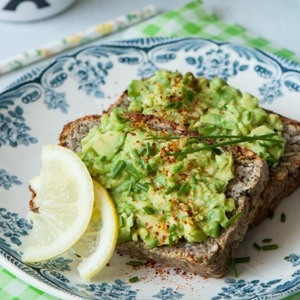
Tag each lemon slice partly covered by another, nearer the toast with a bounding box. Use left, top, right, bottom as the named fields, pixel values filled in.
left=73, top=181, right=119, bottom=280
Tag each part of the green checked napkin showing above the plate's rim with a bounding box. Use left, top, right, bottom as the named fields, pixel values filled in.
left=123, top=0, right=300, bottom=62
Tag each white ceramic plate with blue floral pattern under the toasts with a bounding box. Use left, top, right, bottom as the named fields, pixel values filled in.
left=0, top=38, right=300, bottom=300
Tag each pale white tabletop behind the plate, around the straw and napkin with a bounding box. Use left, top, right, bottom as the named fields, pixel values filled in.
left=0, top=0, right=300, bottom=91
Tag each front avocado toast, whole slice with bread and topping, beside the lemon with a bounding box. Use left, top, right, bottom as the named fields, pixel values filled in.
left=60, top=109, right=268, bottom=277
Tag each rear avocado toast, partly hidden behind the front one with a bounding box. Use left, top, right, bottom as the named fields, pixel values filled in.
left=105, top=70, right=300, bottom=226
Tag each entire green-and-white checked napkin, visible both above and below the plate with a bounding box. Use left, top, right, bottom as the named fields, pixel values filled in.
left=0, top=1, right=300, bottom=300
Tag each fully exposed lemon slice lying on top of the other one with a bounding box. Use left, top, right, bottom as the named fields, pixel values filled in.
left=22, top=145, right=94, bottom=262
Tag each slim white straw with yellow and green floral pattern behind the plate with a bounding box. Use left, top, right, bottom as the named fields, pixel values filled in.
left=0, top=5, right=157, bottom=75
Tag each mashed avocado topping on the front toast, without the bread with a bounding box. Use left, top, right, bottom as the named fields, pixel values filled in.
left=78, top=109, right=235, bottom=248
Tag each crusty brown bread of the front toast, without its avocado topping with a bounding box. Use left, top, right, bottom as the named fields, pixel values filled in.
left=59, top=113, right=268, bottom=278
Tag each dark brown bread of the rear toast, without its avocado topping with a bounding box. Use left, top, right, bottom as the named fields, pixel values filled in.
left=107, top=91, right=300, bottom=227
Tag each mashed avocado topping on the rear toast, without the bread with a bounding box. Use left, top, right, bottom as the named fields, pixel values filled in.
left=128, top=71, right=284, bottom=166
